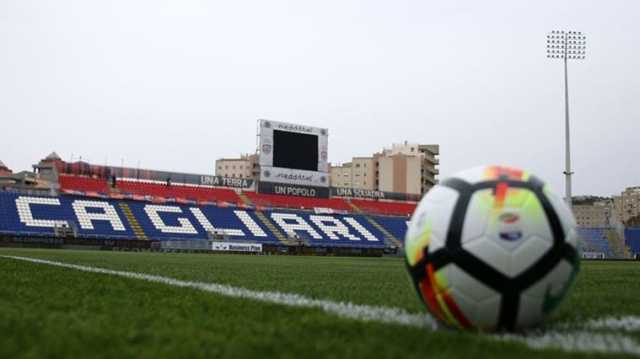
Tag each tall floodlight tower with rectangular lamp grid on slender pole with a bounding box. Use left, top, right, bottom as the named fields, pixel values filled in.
left=547, top=30, right=587, bottom=208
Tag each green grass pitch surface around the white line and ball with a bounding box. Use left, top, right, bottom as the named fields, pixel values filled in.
left=0, top=248, right=640, bottom=358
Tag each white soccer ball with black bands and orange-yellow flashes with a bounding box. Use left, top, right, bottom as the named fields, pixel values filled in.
left=405, top=166, right=579, bottom=331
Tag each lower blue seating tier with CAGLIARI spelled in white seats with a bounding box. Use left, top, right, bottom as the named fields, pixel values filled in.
left=0, top=191, right=385, bottom=248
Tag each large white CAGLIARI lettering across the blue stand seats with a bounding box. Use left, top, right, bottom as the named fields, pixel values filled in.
left=10, top=195, right=381, bottom=243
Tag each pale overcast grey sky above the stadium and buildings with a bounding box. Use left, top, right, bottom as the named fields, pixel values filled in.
left=0, top=0, right=640, bottom=195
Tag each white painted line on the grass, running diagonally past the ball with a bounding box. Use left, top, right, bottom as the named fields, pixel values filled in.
left=0, top=255, right=640, bottom=356
